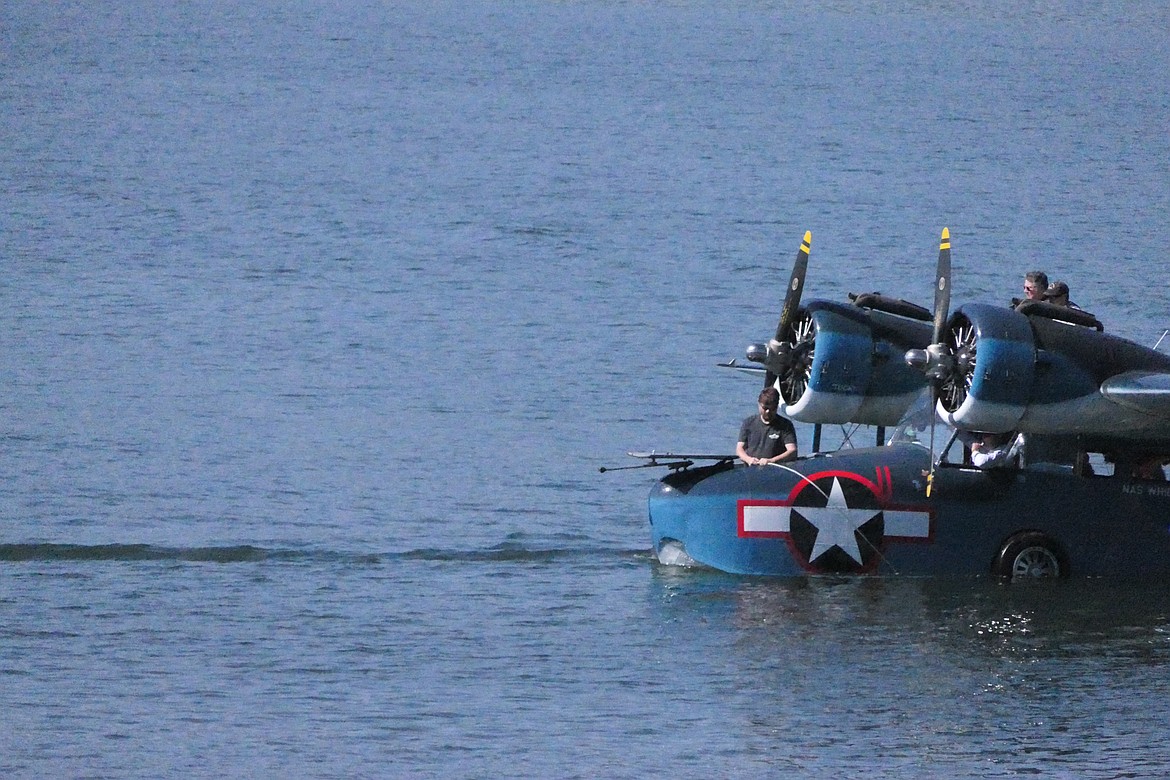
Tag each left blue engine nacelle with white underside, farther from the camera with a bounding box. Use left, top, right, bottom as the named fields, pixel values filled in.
left=779, top=301, right=930, bottom=426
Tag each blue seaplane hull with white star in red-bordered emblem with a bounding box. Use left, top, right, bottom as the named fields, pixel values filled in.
left=649, top=443, right=1170, bottom=578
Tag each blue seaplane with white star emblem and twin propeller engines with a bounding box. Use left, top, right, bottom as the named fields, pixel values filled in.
left=617, top=229, right=1170, bottom=580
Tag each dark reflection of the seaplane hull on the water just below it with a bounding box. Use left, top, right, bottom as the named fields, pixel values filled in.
left=654, top=566, right=1170, bottom=661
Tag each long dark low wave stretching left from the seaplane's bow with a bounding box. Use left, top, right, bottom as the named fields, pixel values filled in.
left=0, top=543, right=649, bottom=565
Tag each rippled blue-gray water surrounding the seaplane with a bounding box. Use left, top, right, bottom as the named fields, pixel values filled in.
left=0, top=0, right=1170, bottom=778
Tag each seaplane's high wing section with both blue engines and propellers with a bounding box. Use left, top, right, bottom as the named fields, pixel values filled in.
left=739, top=229, right=1170, bottom=447
